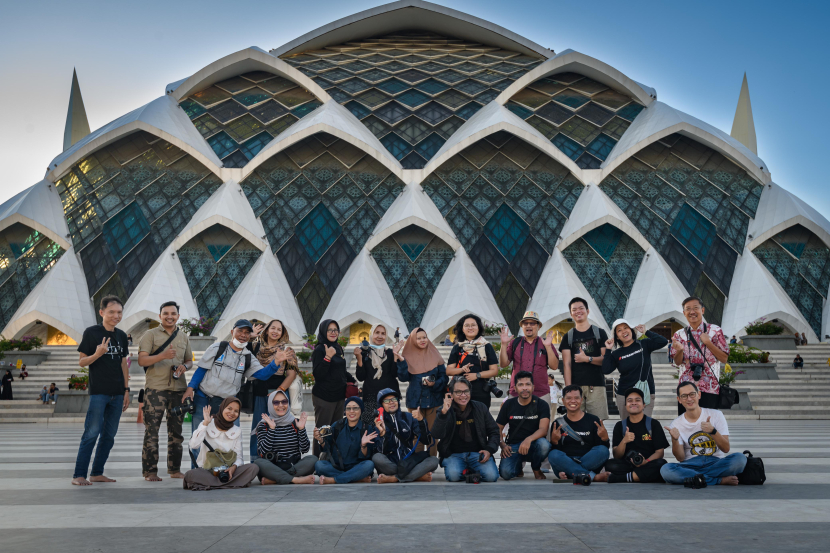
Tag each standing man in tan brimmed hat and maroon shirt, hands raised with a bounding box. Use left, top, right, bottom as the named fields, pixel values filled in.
left=499, top=311, right=559, bottom=405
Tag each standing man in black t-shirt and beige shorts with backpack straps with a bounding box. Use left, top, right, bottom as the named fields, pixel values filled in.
left=559, top=298, right=608, bottom=419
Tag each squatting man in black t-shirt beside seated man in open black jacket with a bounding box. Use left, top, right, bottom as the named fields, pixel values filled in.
left=496, top=371, right=550, bottom=480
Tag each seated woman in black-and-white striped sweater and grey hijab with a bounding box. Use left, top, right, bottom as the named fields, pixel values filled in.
left=254, top=390, right=317, bottom=486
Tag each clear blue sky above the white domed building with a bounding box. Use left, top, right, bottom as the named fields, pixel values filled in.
left=0, top=0, right=830, bottom=213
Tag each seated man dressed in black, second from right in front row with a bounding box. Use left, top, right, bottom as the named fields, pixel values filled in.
left=596, top=388, right=669, bottom=484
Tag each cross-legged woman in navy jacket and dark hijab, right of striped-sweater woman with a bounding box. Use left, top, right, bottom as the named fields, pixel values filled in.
left=314, top=396, right=378, bottom=484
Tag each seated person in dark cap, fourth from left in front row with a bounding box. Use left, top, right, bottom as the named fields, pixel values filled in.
left=372, top=388, right=438, bottom=484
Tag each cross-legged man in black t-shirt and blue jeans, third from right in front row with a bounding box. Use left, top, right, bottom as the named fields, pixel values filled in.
left=548, top=384, right=608, bottom=479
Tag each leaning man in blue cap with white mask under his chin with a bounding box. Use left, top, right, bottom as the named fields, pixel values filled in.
left=182, top=319, right=280, bottom=453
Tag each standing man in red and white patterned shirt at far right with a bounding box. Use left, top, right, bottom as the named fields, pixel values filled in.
left=671, top=296, right=729, bottom=415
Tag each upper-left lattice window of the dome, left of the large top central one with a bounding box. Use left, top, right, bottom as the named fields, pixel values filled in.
left=179, top=71, right=322, bottom=167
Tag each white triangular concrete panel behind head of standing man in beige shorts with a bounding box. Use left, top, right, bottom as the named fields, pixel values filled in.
left=528, top=249, right=609, bottom=331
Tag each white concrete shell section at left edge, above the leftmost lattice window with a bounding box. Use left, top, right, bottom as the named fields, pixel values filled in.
left=0, top=179, right=72, bottom=250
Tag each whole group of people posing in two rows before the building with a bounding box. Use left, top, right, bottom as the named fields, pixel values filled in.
left=72, top=296, right=746, bottom=490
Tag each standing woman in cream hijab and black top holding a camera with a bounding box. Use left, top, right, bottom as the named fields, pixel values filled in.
left=354, top=324, right=401, bottom=425
